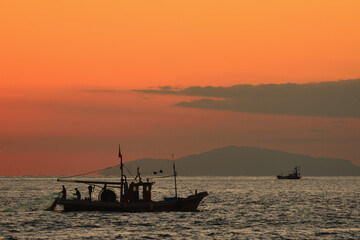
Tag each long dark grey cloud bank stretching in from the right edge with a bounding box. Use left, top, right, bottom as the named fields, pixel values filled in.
left=135, top=79, right=360, bottom=118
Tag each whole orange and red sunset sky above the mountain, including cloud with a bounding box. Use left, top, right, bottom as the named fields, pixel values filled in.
left=0, top=0, right=360, bottom=175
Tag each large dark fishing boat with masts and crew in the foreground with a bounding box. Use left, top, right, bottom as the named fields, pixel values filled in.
left=48, top=145, right=208, bottom=212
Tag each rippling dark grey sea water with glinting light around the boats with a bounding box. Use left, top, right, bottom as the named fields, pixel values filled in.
left=0, top=177, right=360, bottom=239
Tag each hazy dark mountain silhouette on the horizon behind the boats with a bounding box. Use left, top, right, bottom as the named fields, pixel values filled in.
left=100, top=146, right=360, bottom=176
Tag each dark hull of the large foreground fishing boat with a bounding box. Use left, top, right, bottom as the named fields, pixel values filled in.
left=51, top=192, right=208, bottom=212
